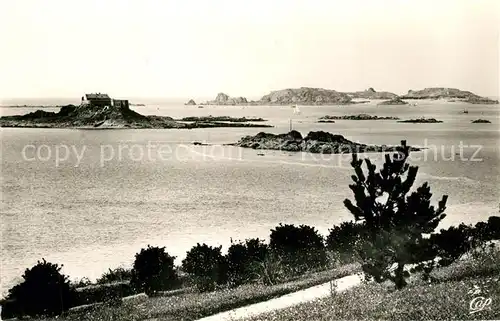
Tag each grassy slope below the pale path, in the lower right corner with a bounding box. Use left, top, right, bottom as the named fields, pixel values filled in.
left=247, top=246, right=500, bottom=321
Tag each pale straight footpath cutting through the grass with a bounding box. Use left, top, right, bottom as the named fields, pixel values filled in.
left=198, top=274, right=362, bottom=321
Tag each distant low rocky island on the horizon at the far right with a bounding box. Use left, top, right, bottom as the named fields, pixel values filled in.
left=401, top=87, right=498, bottom=104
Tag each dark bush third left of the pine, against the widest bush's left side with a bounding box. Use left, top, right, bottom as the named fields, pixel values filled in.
left=226, top=238, right=267, bottom=286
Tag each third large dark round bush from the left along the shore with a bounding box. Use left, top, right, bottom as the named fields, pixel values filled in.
left=182, top=243, right=227, bottom=292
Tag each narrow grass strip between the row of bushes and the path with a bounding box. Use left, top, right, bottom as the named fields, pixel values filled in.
left=38, top=264, right=360, bottom=321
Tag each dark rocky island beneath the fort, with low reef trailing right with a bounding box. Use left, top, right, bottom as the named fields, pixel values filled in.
left=0, top=105, right=272, bottom=129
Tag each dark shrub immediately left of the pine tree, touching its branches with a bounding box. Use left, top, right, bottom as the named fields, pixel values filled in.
left=326, top=222, right=365, bottom=263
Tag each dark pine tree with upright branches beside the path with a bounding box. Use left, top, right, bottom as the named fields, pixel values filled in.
left=344, top=140, right=448, bottom=289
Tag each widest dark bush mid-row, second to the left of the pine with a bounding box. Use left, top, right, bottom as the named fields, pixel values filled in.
left=269, top=224, right=327, bottom=275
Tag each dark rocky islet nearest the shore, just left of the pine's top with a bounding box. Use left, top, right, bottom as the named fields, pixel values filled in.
left=234, top=130, right=419, bottom=154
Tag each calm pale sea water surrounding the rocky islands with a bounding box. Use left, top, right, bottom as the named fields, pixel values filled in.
left=0, top=102, right=500, bottom=291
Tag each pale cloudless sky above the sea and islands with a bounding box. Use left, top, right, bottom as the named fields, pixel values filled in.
left=0, top=0, right=500, bottom=99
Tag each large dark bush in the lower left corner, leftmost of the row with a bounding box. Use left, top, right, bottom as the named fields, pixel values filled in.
left=7, top=259, right=74, bottom=316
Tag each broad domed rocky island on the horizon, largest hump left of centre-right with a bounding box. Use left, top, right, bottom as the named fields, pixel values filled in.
left=259, top=87, right=352, bottom=105
